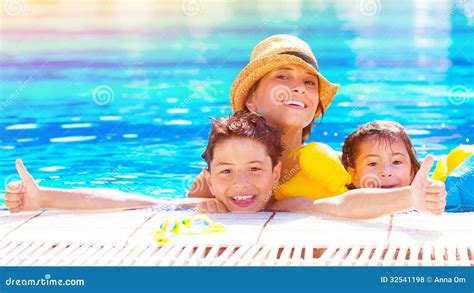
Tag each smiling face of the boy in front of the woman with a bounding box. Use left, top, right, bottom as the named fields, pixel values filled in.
left=204, top=138, right=281, bottom=212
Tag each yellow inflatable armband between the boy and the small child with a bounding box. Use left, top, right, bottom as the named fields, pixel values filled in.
left=275, top=142, right=351, bottom=200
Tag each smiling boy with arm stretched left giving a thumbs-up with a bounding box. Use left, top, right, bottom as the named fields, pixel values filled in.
left=5, top=113, right=283, bottom=212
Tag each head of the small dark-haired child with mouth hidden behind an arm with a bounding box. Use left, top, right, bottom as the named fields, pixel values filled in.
left=342, top=121, right=420, bottom=189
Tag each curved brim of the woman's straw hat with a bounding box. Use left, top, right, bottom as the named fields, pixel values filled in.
left=230, top=54, right=339, bottom=119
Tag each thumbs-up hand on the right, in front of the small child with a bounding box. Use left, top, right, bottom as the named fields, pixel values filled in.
left=411, top=156, right=447, bottom=215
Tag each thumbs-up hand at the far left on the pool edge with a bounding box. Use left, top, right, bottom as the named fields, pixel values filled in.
left=5, top=159, right=41, bottom=213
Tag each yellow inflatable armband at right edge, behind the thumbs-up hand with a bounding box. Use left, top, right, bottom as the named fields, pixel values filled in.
left=432, top=144, right=474, bottom=182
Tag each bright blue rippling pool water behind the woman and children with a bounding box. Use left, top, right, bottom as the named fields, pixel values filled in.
left=0, top=1, right=474, bottom=208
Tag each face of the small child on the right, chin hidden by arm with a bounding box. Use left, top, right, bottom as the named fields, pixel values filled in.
left=348, top=139, right=414, bottom=188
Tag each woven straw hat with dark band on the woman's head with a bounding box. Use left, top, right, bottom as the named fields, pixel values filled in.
left=230, top=35, right=339, bottom=119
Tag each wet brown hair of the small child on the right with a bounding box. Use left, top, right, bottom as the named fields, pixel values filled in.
left=342, top=121, right=420, bottom=187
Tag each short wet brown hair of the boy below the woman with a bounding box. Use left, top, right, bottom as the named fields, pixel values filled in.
left=202, top=111, right=283, bottom=170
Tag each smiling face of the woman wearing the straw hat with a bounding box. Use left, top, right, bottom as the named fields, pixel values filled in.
left=246, top=65, right=319, bottom=131
